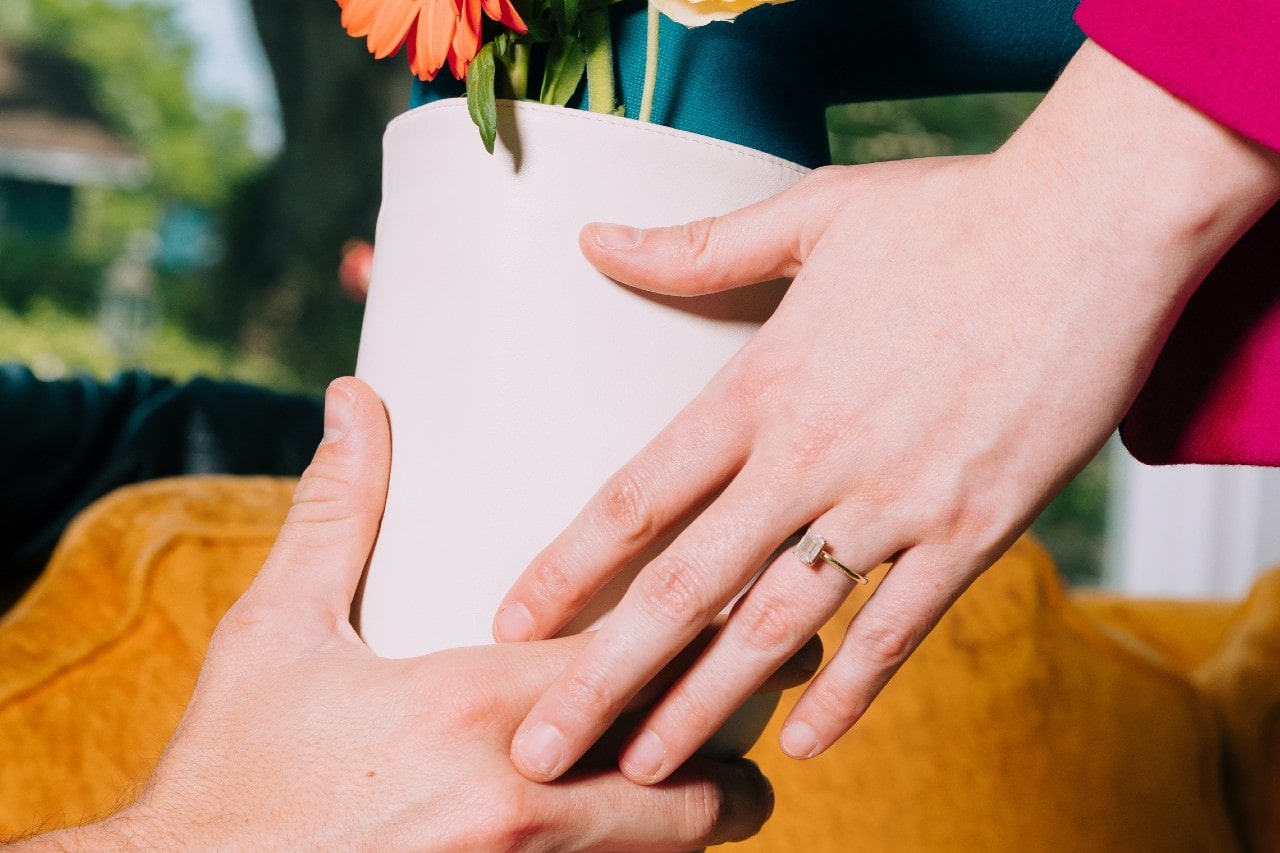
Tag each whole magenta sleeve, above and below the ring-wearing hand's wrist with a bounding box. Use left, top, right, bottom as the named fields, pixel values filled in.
left=1075, top=0, right=1280, bottom=466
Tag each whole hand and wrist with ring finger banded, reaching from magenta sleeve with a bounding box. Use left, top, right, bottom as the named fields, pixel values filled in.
left=495, top=44, right=1280, bottom=783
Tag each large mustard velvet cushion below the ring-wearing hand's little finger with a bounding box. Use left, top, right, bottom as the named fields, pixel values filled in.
left=735, top=539, right=1238, bottom=853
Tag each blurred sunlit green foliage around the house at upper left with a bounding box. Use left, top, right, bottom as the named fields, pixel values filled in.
left=0, top=0, right=301, bottom=388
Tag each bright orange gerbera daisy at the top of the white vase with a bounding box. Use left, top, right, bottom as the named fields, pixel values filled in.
left=338, top=0, right=529, bottom=79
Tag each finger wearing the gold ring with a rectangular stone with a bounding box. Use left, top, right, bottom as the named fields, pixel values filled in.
left=620, top=508, right=892, bottom=784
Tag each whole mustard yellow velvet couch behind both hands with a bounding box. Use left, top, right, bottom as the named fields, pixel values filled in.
left=0, top=478, right=1280, bottom=853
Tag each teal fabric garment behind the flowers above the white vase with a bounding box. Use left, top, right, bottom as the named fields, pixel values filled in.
left=412, top=0, right=1084, bottom=167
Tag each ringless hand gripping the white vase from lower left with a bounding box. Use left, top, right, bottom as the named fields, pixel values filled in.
left=19, top=379, right=778, bottom=850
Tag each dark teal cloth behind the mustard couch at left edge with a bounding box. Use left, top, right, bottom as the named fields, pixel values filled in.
left=0, top=365, right=323, bottom=611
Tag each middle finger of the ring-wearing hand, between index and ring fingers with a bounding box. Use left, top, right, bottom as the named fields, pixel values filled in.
left=512, top=467, right=797, bottom=781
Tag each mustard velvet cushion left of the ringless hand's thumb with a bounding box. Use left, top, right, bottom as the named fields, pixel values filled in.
left=0, top=478, right=294, bottom=838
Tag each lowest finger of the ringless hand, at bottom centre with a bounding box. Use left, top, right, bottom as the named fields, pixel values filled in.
left=531, top=758, right=773, bottom=852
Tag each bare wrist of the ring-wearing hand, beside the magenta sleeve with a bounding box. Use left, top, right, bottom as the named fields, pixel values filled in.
left=993, top=42, right=1280, bottom=305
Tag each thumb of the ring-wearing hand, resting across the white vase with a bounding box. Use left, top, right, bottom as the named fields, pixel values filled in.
left=579, top=168, right=849, bottom=296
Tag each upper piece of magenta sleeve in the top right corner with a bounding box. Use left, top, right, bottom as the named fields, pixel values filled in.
left=1075, top=0, right=1280, bottom=151
